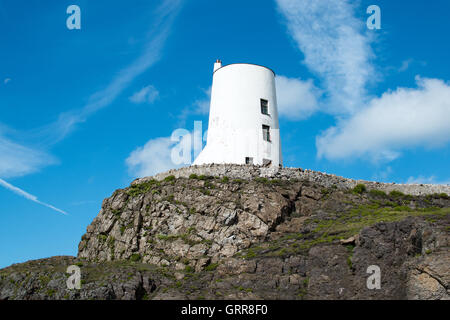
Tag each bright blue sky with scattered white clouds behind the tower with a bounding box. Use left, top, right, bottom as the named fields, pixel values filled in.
left=0, top=0, right=450, bottom=267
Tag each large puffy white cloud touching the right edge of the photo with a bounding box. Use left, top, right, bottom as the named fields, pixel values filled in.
left=316, top=77, right=450, bottom=161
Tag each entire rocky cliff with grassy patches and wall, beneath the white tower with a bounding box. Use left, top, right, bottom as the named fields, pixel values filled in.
left=0, top=166, right=450, bottom=299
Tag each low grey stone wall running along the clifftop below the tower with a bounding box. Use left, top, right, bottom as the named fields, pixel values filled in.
left=132, top=164, right=450, bottom=195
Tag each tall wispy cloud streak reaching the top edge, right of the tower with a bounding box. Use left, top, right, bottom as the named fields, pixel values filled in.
left=276, top=0, right=374, bottom=114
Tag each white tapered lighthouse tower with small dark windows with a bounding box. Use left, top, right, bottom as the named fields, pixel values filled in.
left=194, top=60, right=282, bottom=166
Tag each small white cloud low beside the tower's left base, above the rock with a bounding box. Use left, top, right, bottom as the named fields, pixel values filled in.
left=125, top=137, right=185, bottom=177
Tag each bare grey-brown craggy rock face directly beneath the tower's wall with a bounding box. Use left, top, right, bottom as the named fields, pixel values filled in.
left=78, top=175, right=301, bottom=267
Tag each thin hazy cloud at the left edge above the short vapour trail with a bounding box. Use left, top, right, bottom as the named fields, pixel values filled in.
left=0, top=133, right=57, bottom=178
